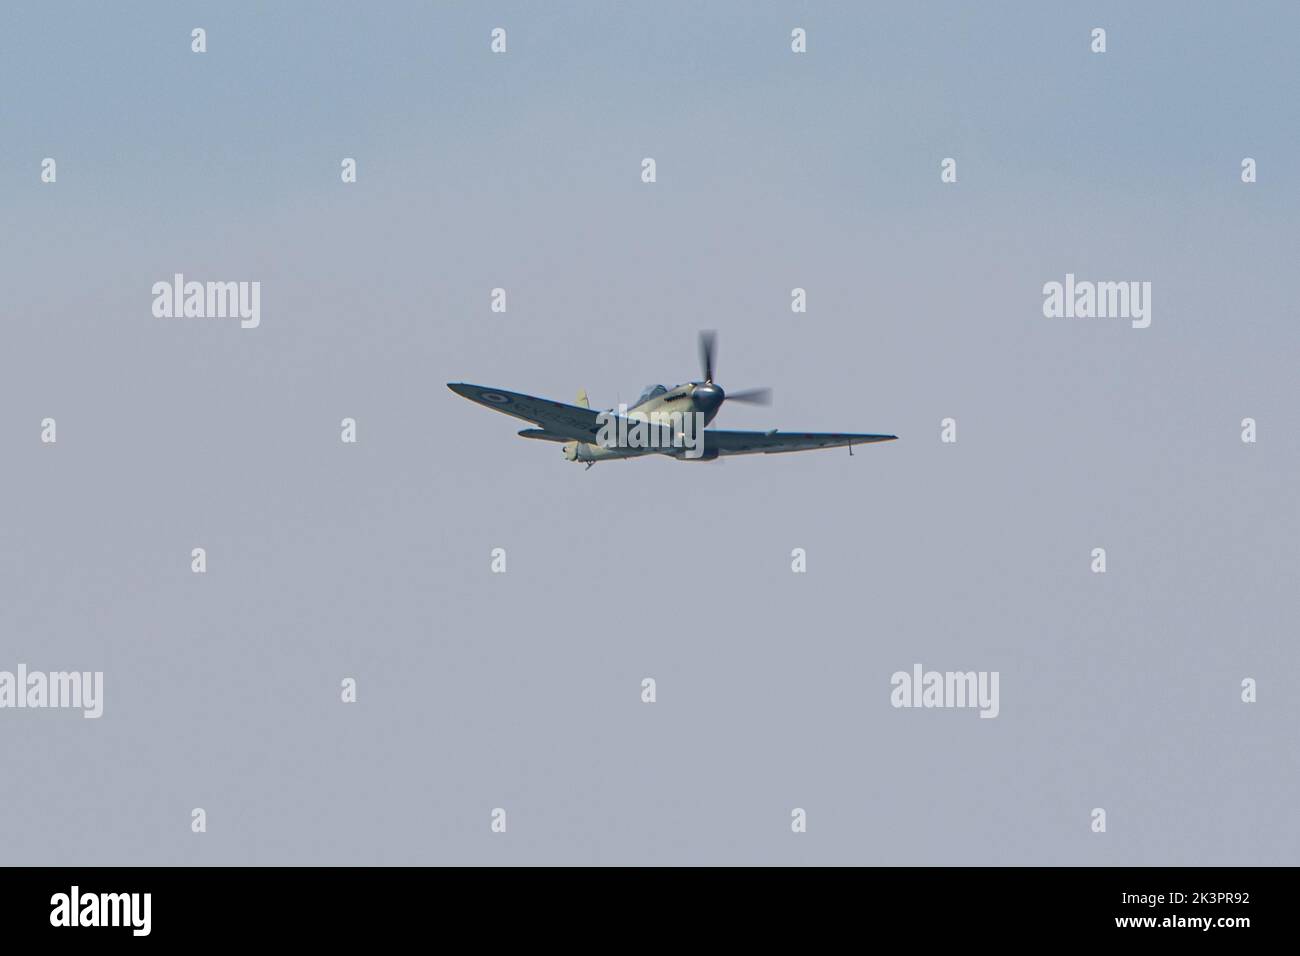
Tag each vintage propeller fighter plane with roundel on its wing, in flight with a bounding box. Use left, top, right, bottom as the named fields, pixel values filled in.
left=447, top=332, right=898, bottom=468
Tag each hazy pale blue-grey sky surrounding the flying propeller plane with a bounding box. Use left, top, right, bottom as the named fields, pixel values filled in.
left=0, top=0, right=1300, bottom=865
